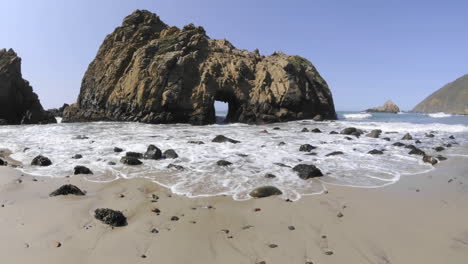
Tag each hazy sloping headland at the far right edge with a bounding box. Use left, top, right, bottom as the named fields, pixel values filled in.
left=413, top=74, right=468, bottom=115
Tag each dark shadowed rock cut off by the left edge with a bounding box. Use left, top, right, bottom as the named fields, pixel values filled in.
left=0, top=49, right=56, bottom=125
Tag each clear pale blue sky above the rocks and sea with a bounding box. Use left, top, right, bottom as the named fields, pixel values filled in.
left=0, top=0, right=468, bottom=110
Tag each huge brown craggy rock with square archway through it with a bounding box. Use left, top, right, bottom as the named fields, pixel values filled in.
left=63, top=10, right=336, bottom=124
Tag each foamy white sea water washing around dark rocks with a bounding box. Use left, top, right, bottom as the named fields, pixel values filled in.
left=0, top=112, right=468, bottom=200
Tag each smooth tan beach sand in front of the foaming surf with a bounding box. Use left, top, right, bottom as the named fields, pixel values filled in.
left=0, top=157, right=468, bottom=264
